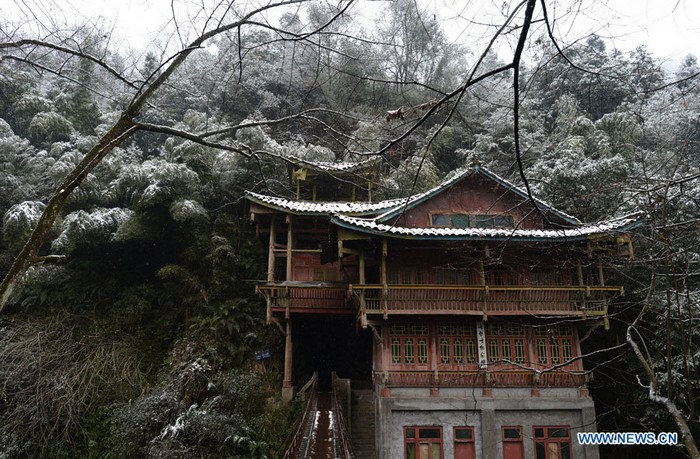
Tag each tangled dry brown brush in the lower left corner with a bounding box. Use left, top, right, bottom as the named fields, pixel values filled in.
left=0, top=316, right=142, bottom=457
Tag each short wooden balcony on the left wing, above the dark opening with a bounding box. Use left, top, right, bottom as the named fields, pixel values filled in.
left=256, top=282, right=357, bottom=319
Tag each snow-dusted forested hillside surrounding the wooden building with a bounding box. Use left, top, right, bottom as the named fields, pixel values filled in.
left=0, top=0, right=700, bottom=458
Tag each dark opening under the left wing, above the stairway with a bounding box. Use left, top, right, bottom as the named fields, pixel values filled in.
left=292, top=316, right=372, bottom=392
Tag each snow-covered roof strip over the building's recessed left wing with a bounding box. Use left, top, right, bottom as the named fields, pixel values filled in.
left=246, top=191, right=407, bottom=216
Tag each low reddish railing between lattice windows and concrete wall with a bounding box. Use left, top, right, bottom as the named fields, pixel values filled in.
left=374, top=370, right=589, bottom=387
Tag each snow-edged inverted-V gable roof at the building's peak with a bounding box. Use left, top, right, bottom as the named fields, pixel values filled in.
left=377, top=165, right=581, bottom=225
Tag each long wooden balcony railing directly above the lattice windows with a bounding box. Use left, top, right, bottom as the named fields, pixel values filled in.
left=349, top=285, right=624, bottom=318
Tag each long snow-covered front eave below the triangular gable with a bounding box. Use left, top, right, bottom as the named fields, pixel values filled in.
left=331, top=213, right=641, bottom=241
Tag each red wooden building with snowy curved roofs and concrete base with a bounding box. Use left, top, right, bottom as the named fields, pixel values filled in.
left=247, top=164, right=638, bottom=459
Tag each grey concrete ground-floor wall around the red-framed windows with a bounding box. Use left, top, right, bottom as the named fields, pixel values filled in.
left=376, top=388, right=599, bottom=459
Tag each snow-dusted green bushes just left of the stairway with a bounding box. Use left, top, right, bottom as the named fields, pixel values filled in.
left=109, top=359, right=296, bottom=458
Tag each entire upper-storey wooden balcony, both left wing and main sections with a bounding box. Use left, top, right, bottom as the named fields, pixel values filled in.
left=258, top=282, right=624, bottom=325
